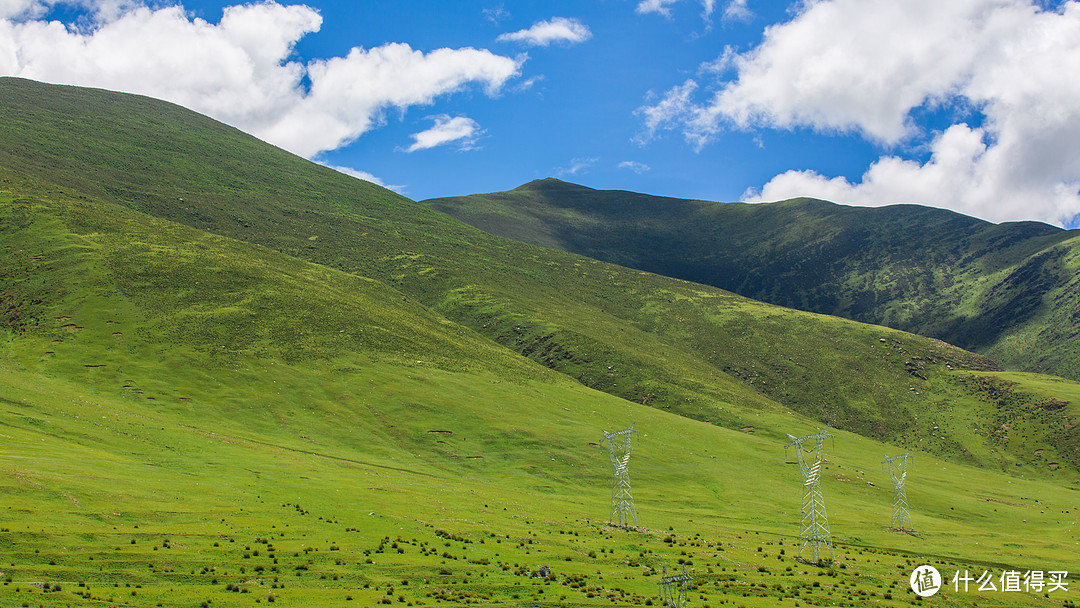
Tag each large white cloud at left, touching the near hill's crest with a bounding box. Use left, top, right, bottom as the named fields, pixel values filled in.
left=0, top=0, right=521, bottom=157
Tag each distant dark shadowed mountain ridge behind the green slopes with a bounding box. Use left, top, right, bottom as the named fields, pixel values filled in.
left=424, top=179, right=1080, bottom=379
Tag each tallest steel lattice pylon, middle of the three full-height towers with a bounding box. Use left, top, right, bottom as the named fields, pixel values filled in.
left=784, top=425, right=835, bottom=565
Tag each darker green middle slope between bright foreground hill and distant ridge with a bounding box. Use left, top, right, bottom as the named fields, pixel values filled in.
left=8, top=79, right=1080, bottom=483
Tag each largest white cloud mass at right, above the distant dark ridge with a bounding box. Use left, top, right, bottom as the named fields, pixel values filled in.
left=638, top=0, right=1080, bottom=225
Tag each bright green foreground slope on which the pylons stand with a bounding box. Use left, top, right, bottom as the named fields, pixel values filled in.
left=0, top=168, right=1080, bottom=607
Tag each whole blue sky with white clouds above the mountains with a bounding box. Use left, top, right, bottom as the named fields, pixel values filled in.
left=0, top=0, right=1080, bottom=227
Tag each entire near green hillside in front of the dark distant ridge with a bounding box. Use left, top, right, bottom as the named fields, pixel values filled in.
left=0, top=79, right=1080, bottom=607
